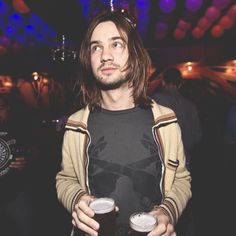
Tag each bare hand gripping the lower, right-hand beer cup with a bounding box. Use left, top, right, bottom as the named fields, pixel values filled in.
left=148, top=211, right=176, bottom=236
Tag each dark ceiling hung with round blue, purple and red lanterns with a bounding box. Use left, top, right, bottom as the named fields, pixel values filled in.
left=0, top=0, right=236, bottom=75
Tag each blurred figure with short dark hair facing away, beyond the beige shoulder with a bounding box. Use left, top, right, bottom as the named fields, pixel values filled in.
left=151, top=67, right=202, bottom=170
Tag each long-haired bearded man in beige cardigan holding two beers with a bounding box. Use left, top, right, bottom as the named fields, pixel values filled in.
left=56, top=11, right=191, bottom=236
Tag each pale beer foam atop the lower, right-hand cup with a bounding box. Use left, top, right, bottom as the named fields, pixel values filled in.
left=130, top=213, right=156, bottom=232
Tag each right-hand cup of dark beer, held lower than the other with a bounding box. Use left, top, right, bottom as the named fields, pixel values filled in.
left=129, top=212, right=157, bottom=236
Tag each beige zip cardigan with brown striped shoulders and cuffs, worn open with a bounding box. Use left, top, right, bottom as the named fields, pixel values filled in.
left=56, top=101, right=191, bottom=235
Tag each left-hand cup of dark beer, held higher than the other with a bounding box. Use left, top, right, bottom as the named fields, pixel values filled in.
left=89, top=198, right=116, bottom=236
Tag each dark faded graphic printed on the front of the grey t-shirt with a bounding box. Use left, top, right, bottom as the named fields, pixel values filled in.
left=89, top=135, right=161, bottom=210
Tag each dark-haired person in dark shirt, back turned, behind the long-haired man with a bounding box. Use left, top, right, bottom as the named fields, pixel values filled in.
left=151, top=67, right=202, bottom=236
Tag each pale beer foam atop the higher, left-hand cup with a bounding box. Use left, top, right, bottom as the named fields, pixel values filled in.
left=89, top=198, right=114, bottom=214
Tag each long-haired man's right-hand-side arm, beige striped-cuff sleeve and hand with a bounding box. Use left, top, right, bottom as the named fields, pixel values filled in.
left=149, top=123, right=191, bottom=236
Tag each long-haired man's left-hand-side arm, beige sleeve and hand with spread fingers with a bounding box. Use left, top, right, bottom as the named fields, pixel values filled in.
left=56, top=130, right=99, bottom=235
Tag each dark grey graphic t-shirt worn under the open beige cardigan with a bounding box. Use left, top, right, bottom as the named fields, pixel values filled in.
left=88, top=108, right=162, bottom=236
